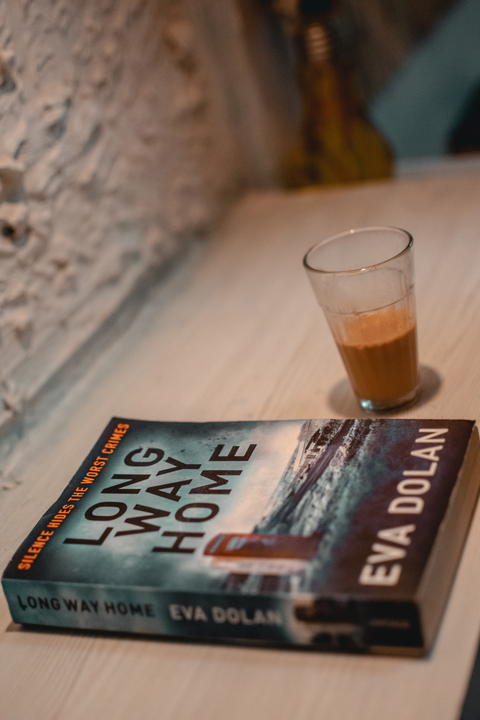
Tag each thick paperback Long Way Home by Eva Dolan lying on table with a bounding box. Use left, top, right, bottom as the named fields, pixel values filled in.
left=2, top=418, right=480, bottom=655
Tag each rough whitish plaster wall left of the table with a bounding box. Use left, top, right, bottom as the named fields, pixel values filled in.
left=0, top=0, right=242, bottom=419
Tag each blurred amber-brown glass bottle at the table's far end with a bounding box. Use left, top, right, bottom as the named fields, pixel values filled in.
left=284, top=0, right=393, bottom=187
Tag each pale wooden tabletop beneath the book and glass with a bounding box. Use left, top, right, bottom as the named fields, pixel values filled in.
left=0, top=167, right=480, bottom=720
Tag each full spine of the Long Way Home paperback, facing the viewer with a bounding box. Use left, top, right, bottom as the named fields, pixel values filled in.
left=3, top=578, right=423, bottom=654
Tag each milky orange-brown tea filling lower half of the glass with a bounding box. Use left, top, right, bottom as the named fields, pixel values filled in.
left=335, top=308, right=418, bottom=409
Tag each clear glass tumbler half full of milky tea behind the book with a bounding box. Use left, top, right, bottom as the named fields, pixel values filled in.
left=303, top=226, right=419, bottom=411
